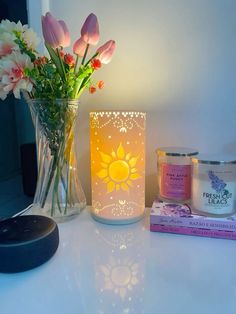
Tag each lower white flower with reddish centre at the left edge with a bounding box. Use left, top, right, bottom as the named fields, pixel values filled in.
left=0, top=52, right=33, bottom=100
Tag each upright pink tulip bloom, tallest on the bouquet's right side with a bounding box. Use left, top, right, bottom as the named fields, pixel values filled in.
left=81, top=13, right=99, bottom=46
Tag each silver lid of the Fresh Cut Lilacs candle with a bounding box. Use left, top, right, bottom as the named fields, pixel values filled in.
left=191, top=154, right=236, bottom=165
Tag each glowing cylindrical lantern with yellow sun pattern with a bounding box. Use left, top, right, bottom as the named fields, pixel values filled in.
left=90, top=111, right=146, bottom=224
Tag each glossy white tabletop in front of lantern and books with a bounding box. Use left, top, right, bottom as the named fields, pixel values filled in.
left=0, top=206, right=236, bottom=314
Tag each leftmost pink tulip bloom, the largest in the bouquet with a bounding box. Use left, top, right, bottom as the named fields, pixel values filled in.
left=42, top=12, right=70, bottom=49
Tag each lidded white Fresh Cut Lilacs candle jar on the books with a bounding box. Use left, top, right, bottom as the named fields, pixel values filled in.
left=192, top=156, right=236, bottom=217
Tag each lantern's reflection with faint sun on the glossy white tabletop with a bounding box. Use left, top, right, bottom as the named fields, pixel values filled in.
left=93, top=222, right=145, bottom=313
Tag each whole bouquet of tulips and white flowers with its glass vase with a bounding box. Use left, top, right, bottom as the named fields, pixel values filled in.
left=0, top=12, right=115, bottom=221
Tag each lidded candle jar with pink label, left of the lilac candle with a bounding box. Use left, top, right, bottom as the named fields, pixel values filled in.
left=156, top=147, right=198, bottom=203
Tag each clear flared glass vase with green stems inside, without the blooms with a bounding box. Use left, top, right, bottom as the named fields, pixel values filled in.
left=25, top=97, right=86, bottom=222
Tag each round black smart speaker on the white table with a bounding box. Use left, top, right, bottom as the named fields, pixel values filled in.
left=0, top=215, right=59, bottom=273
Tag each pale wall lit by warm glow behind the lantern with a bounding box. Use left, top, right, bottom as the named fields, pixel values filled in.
left=28, top=0, right=236, bottom=206
